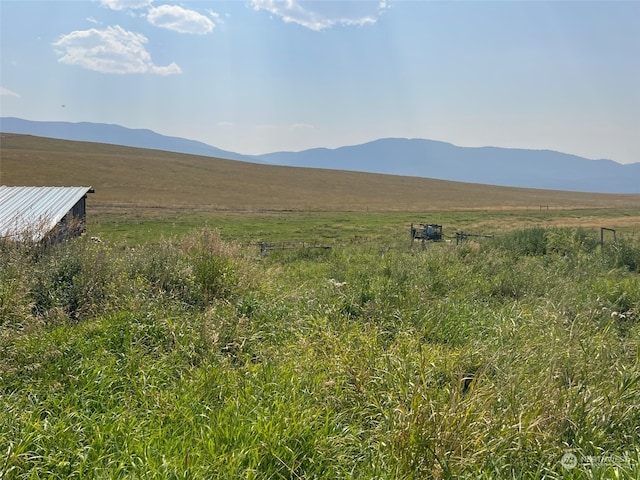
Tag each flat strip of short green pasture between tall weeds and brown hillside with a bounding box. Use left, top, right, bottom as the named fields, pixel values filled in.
left=88, top=207, right=640, bottom=245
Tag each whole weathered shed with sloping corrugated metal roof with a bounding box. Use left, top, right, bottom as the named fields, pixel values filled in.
left=0, top=186, right=93, bottom=243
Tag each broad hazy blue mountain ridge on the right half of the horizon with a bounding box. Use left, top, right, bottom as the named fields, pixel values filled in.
left=260, top=138, right=640, bottom=193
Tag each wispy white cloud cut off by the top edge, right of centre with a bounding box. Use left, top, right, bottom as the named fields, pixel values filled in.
left=251, top=0, right=387, bottom=32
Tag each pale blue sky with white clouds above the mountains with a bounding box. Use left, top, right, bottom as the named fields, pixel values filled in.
left=0, top=0, right=640, bottom=163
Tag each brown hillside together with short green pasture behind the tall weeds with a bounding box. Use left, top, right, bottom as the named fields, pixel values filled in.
left=0, top=134, right=640, bottom=242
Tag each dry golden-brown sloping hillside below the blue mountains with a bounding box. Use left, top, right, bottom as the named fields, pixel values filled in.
left=0, top=133, right=640, bottom=212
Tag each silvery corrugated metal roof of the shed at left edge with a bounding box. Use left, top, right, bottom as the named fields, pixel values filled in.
left=0, top=186, right=91, bottom=242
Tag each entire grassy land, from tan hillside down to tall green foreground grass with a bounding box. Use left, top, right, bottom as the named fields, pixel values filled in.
left=0, top=132, right=640, bottom=480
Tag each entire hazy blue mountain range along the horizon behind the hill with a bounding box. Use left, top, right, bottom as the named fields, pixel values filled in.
left=0, top=117, right=640, bottom=193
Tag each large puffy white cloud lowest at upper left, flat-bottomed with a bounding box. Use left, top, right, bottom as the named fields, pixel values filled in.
left=53, top=25, right=182, bottom=75
